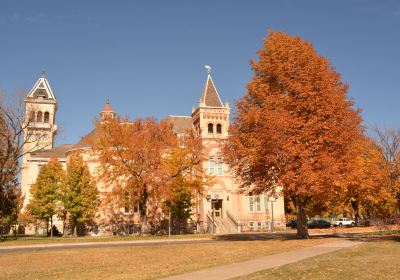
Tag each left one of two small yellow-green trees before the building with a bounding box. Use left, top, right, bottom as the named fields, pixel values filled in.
left=28, top=157, right=65, bottom=237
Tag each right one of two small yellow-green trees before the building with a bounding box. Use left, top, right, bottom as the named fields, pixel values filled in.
left=61, top=153, right=99, bottom=236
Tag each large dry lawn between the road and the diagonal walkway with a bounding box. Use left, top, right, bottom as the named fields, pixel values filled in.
left=0, top=238, right=337, bottom=280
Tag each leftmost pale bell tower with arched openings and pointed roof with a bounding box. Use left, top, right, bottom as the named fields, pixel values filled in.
left=24, top=72, right=57, bottom=162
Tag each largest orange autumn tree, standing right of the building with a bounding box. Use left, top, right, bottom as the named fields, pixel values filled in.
left=226, top=31, right=362, bottom=241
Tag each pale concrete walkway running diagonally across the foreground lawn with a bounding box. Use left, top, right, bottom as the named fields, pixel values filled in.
left=164, top=240, right=363, bottom=280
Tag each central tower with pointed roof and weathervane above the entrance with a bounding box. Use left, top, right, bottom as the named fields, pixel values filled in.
left=192, top=66, right=233, bottom=221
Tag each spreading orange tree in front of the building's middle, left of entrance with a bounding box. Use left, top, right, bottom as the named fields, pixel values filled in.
left=94, top=117, right=200, bottom=233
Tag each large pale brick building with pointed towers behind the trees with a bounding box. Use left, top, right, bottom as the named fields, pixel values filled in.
left=21, top=73, right=285, bottom=234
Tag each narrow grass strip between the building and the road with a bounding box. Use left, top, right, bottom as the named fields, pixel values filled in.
left=0, top=234, right=213, bottom=246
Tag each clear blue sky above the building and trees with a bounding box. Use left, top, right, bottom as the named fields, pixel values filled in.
left=0, top=0, right=400, bottom=144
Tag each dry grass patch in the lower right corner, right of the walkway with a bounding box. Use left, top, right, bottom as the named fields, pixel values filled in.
left=237, top=240, right=400, bottom=280
